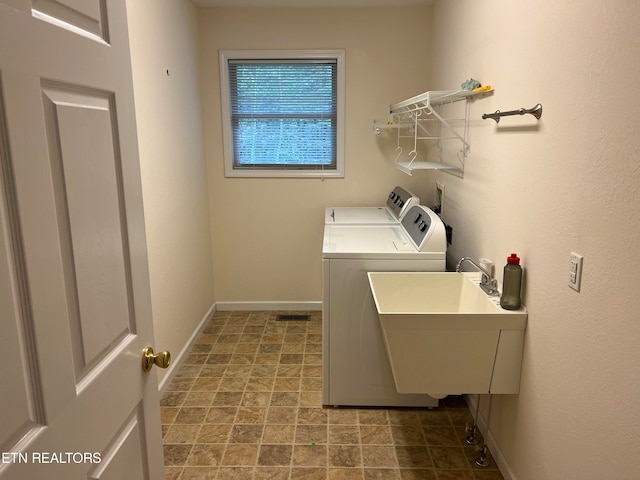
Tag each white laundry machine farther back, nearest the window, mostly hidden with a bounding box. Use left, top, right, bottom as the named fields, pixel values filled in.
left=324, top=186, right=420, bottom=225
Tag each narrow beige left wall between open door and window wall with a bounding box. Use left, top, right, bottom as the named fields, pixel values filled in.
left=127, top=0, right=214, bottom=384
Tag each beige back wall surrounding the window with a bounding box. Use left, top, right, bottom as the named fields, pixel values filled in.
left=199, top=7, right=435, bottom=302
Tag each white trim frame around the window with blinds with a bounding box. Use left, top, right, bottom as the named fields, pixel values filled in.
left=219, top=50, right=345, bottom=178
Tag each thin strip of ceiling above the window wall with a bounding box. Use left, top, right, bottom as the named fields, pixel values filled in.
left=191, top=0, right=434, bottom=8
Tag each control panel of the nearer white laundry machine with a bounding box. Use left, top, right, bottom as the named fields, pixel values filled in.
left=401, top=205, right=447, bottom=252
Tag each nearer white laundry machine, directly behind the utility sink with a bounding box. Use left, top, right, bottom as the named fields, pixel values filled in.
left=322, top=205, right=447, bottom=407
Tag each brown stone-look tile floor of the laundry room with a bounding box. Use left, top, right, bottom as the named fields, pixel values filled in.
left=161, top=312, right=503, bottom=480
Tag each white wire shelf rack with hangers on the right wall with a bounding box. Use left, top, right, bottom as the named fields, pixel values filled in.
left=373, top=89, right=493, bottom=177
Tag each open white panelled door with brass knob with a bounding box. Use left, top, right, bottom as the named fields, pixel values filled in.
left=0, top=0, right=164, bottom=480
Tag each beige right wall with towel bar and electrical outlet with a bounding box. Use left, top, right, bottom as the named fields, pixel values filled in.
left=431, top=0, right=640, bottom=480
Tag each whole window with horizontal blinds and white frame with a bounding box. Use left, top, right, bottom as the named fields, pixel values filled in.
left=220, top=50, right=344, bottom=177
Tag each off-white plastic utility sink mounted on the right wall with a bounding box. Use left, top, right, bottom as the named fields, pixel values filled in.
left=368, top=272, right=527, bottom=397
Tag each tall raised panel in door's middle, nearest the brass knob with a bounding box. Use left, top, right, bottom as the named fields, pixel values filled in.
left=43, top=85, right=133, bottom=377
